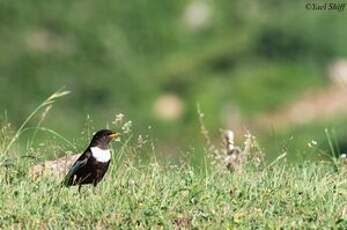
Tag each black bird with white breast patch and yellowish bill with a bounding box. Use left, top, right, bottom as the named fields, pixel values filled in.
left=64, top=129, right=119, bottom=191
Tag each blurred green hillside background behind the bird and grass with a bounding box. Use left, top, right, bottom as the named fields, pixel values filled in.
left=0, top=0, right=347, bottom=160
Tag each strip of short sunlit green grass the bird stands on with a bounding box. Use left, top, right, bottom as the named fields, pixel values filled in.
left=0, top=142, right=347, bottom=229
